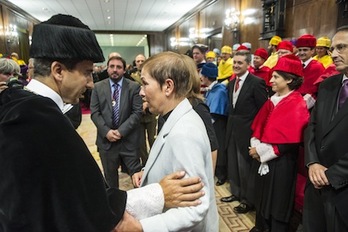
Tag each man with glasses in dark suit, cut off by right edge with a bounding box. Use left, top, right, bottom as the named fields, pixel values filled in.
left=303, top=26, right=348, bottom=232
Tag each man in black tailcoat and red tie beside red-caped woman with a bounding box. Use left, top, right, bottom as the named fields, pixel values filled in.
left=221, top=51, right=267, bottom=213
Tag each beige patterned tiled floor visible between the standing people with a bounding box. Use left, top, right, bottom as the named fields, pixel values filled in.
left=77, top=114, right=255, bottom=232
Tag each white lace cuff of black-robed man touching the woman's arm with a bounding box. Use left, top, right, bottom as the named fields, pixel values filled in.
left=126, top=183, right=164, bottom=220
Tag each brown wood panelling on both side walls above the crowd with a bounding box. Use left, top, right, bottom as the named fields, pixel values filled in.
left=0, top=0, right=338, bottom=60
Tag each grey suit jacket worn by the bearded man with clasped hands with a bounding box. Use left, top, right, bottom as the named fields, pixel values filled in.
left=90, top=78, right=142, bottom=150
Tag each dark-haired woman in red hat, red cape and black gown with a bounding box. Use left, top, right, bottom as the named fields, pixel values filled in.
left=249, top=54, right=309, bottom=232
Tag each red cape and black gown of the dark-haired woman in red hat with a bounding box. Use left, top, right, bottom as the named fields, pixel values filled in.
left=252, top=91, right=309, bottom=223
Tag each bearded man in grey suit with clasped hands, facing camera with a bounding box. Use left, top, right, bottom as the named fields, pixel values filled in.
left=91, top=56, right=142, bottom=187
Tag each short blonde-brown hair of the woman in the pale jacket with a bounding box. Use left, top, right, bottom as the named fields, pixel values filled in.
left=142, top=52, right=198, bottom=98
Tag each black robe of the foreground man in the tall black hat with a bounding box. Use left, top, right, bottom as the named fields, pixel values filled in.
left=0, top=90, right=127, bottom=232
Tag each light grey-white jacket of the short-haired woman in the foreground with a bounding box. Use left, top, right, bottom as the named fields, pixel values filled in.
left=141, top=99, right=219, bottom=232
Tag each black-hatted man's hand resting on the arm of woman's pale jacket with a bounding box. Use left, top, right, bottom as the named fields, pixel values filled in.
left=159, top=171, right=205, bottom=208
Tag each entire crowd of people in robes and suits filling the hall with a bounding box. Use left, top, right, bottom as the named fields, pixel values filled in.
left=0, top=8, right=348, bottom=232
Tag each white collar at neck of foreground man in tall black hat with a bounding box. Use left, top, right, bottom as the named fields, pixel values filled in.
left=26, top=79, right=65, bottom=113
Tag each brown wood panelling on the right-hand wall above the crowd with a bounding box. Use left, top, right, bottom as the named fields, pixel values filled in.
left=164, top=0, right=337, bottom=52
